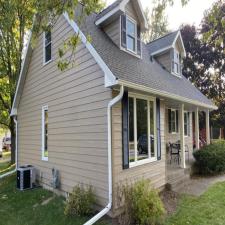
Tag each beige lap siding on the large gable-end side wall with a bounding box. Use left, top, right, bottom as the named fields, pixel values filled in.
left=18, top=14, right=112, bottom=206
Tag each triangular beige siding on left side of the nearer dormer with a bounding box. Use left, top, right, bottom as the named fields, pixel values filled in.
left=103, top=17, right=120, bottom=47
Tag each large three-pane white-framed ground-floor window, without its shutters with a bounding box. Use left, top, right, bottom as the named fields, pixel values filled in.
left=128, top=95, right=157, bottom=166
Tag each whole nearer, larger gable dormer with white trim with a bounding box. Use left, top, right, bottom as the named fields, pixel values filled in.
left=95, top=0, right=147, bottom=57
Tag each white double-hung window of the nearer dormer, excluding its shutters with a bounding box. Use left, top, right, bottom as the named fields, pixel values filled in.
left=126, top=17, right=137, bottom=52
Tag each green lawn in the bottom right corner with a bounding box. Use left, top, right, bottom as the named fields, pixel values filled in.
left=166, top=182, right=225, bottom=225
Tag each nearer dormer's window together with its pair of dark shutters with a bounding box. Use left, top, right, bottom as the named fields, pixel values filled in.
left=121, top=15, right=141, bottom=56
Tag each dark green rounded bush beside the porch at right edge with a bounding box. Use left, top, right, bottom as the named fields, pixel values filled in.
left=193, top=141, right=225, bottom=175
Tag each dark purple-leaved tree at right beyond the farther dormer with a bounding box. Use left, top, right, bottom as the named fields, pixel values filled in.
left=181, top=0, right=225, bottom=130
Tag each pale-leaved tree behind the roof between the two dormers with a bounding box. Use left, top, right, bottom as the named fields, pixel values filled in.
left=142, top=0, right=189, bottom=43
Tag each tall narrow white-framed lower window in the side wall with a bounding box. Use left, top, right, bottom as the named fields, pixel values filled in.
left=42, top=106, right=48, bottom=161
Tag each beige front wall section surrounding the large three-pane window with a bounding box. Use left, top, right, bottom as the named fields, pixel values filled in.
left=112, top=90, right=166, bottom=215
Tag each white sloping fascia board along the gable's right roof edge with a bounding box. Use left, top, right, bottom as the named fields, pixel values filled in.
left=63, top=13, right=117, bottom=87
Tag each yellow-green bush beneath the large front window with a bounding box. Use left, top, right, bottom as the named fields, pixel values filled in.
left=119, top=180, right=165, bottom=225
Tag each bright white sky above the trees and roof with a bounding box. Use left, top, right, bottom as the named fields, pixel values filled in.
left=106, top=0, right=215, bottom=30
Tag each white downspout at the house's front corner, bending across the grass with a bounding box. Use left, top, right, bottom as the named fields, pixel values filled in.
left=84, top=85, right=124, bottom=225
